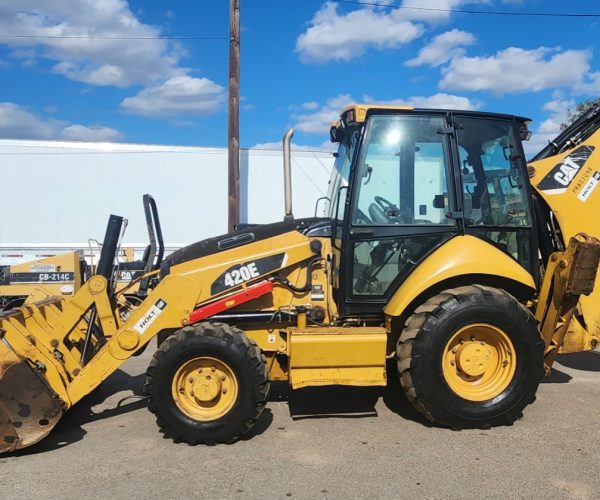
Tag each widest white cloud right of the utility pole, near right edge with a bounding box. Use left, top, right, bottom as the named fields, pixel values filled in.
left=439, top=47, right=591, bottom=94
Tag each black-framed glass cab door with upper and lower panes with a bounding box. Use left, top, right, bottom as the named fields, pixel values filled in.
left=338, top=111, right=458, bottom=315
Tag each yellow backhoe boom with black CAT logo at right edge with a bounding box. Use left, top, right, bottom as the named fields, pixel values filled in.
left=528, top=107, right=600, bottom=360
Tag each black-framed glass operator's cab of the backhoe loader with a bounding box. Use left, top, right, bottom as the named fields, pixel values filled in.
left=329, top=106, right=538, bottom=315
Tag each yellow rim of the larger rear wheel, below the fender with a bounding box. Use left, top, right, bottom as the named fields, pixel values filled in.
left=442, top=323, right=517, bottom=401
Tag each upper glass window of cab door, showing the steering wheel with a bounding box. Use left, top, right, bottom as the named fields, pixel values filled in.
left=352, top=115, right=453, bottom=225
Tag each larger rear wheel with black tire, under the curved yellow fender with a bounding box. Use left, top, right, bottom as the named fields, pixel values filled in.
left=397, top=285, right=544, bottom=429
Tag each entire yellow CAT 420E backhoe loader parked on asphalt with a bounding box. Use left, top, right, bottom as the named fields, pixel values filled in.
left=0, top=105, right=600, bottom=452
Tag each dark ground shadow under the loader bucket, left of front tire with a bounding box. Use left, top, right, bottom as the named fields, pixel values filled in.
left=6, top=370, right=146, bottom=457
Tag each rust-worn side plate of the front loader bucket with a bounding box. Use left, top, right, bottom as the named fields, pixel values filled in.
left=0, top=339, right=63, bottom=453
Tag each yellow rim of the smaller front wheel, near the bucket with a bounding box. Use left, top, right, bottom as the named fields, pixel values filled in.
left=171, top=357, right=238, bottom=422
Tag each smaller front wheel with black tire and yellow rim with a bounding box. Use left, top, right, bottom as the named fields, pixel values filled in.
left=144, top=323, right=269, bottom=444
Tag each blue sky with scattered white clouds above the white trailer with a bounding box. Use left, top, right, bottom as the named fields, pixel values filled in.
left=0, top=0, right=600, bottom=151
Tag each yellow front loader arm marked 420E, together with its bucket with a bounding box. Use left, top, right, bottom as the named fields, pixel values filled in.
left=0, top=230, right=320, bottom=452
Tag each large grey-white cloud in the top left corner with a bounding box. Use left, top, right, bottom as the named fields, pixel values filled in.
left=0, top=0, right=185, bottom=87
